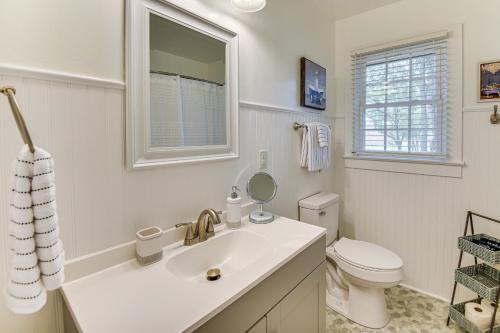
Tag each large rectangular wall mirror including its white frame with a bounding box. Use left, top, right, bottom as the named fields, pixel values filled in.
left=127, top=0, right=239, bottom=169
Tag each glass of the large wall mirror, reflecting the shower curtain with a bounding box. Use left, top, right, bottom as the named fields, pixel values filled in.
left=149, top=13, right=228, bottom=149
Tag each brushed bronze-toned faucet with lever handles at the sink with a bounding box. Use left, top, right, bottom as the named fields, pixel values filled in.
left=175, top=208, right=221, bottom=246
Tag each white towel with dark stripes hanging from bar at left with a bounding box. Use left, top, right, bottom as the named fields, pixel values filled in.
left=7, top=146, right=64, bottom=313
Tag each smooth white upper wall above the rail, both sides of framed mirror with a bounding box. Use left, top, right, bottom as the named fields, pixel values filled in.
left=0, top=0, right=334, bottom=112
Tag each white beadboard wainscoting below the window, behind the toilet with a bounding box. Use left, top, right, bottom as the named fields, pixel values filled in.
left=335, top=107, right=500, bottom=300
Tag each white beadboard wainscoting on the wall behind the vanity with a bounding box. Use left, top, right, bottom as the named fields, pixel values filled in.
left=0, top=68, right=333, bottom=333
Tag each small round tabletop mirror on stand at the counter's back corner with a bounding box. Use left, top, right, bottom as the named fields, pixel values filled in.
left=247, top=172, right=278, bottom=224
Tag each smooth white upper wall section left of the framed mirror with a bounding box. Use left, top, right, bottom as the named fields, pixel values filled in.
left=0, top=0, right=125, bottom=80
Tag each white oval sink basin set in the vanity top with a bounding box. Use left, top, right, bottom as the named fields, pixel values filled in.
left=166, top=230, right=272, bottom=283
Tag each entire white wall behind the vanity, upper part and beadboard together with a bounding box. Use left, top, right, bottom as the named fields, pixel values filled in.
left=0, top=0, right=334, bottom=333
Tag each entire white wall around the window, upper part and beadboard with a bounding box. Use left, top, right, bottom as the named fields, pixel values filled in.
left=335, top=0, right=500, bottom=299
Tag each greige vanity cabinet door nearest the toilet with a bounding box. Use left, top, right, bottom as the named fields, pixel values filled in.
left=266, top=262, right=326, bottom=333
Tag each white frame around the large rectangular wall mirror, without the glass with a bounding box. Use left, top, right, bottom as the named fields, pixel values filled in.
left=126, top=0, right=239, bottom=169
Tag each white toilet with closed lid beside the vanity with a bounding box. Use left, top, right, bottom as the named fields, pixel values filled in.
left=299, top=193, right=403, bottom=328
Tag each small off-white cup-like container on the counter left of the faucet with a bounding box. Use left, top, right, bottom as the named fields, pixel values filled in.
left=135, top=227, right=163, bottom=265
